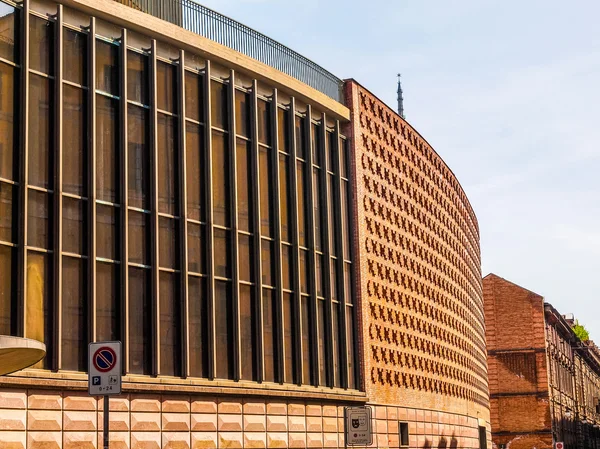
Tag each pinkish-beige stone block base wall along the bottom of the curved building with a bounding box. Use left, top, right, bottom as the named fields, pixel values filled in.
left=0, top=388, right=491, bottom=449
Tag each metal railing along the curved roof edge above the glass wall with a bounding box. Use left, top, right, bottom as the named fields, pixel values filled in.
left=115, top=0, right=343, bottom=103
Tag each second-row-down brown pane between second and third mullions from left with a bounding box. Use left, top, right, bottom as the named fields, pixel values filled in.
left=62, top=84, right=88, bottom=195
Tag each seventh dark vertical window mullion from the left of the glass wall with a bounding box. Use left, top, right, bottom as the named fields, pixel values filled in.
left=204, top=60, right=216, bottom=379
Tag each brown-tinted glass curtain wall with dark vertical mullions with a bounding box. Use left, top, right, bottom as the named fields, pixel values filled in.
left=0, top=2, right=357, bottom=389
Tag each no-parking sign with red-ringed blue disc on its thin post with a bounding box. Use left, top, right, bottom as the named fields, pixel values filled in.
left=88, top=341, right=121, bottom=449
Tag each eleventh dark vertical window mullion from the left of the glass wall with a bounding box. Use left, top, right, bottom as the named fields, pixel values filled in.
left=289, top=97, right=308, bottom=385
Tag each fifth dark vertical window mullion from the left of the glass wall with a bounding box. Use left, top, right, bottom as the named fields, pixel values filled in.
left=150, top=39, right=160, bottom=375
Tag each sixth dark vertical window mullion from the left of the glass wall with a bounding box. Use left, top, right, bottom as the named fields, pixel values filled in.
left=177, top=50, right=190, bottom=378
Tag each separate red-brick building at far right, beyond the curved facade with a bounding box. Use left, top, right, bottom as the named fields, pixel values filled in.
left=483, top=274, right=600, bottom=449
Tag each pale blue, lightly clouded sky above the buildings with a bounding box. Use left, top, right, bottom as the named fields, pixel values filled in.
left=196, top=0, right=600, bottom=332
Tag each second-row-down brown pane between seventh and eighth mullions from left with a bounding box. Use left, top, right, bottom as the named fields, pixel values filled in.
left=212, top=131, right=231, bottom=226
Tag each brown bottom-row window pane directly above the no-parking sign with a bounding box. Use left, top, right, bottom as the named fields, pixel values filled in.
left=96, top=262, right=120, bottom=341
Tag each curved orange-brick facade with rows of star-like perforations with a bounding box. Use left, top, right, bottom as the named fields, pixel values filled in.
left=347, top=82, right=489, bottom=408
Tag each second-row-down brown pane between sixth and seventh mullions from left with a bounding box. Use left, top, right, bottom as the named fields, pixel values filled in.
left=185, top=122, right=208, bottom=221
